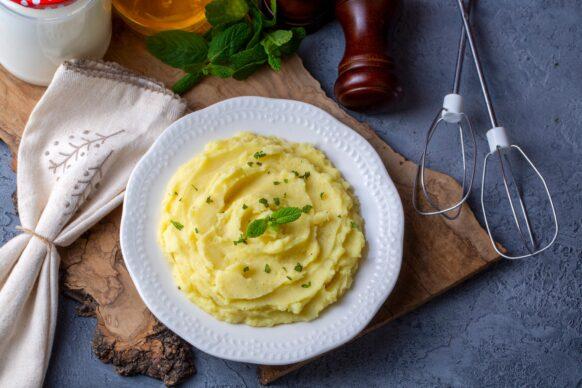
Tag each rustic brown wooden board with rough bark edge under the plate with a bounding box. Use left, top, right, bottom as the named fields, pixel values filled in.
left=0, top=21, right=498, bottom=385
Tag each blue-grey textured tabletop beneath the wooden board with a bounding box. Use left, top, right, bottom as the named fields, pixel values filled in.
left=0, top=0, right=582, bottom=387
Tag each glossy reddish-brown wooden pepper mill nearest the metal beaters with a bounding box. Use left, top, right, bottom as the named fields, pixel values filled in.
left=334, top=0, right=402, bottom=112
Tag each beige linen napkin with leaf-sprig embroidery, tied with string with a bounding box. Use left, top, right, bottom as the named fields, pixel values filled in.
left=0, top=60, right=185, bottom=387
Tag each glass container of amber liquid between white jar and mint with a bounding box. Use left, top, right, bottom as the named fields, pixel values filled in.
left=113, top=0, right=211, bottom=35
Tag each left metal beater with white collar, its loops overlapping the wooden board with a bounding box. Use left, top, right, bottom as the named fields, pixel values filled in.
left=412, top=0, right=477, bottom=220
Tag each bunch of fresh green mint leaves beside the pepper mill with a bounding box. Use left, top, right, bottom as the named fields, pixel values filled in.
left=146, top=0, right=305, bottom=94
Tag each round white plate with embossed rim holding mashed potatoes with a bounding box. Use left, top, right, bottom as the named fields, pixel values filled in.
left=121, top=97, right=404, bottom=365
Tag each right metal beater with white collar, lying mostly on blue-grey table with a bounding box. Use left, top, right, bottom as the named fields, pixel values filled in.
left=457, top=0, right=558, bottom=259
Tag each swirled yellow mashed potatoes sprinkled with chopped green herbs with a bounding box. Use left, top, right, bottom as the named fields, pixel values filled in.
left=159, top=133, right=365, bottom=326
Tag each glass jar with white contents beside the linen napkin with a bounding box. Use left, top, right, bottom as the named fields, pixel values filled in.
left=0, top=0, right=111, bottom=85
